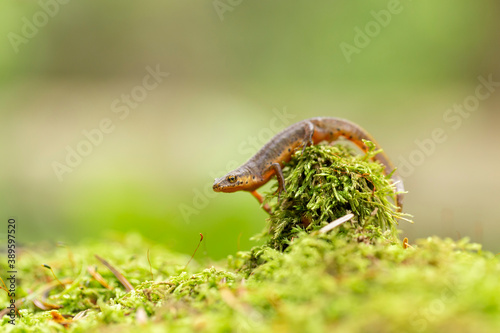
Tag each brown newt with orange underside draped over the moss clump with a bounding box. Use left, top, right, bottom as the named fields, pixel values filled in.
left=213, top=117, right=404, bottom=213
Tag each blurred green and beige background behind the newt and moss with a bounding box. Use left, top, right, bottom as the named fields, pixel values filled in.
left=0, top=0, right=500, bottom=259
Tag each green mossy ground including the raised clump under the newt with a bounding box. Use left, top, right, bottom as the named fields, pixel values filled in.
left=0, top=146, right=500, bottom=332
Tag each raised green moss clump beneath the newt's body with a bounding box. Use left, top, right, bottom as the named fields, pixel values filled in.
left=266, top=141, right=408, bottom=250
